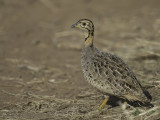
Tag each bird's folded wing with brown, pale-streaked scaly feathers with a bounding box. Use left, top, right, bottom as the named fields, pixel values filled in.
left=94, top=53, right=142, bottom=96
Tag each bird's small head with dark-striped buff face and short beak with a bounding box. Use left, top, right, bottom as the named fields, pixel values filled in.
left=72, top=19, right=94, bottom=33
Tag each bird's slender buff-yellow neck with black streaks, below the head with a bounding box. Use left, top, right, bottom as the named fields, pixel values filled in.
left=84, top=30, right=94, bottom=47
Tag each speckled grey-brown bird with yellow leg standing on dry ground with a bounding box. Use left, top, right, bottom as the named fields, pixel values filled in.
left=72, top=19, right=152, bottom=109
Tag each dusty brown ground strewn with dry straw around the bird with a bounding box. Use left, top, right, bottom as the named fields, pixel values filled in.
left=0, top=0, right=160, bottom=120
